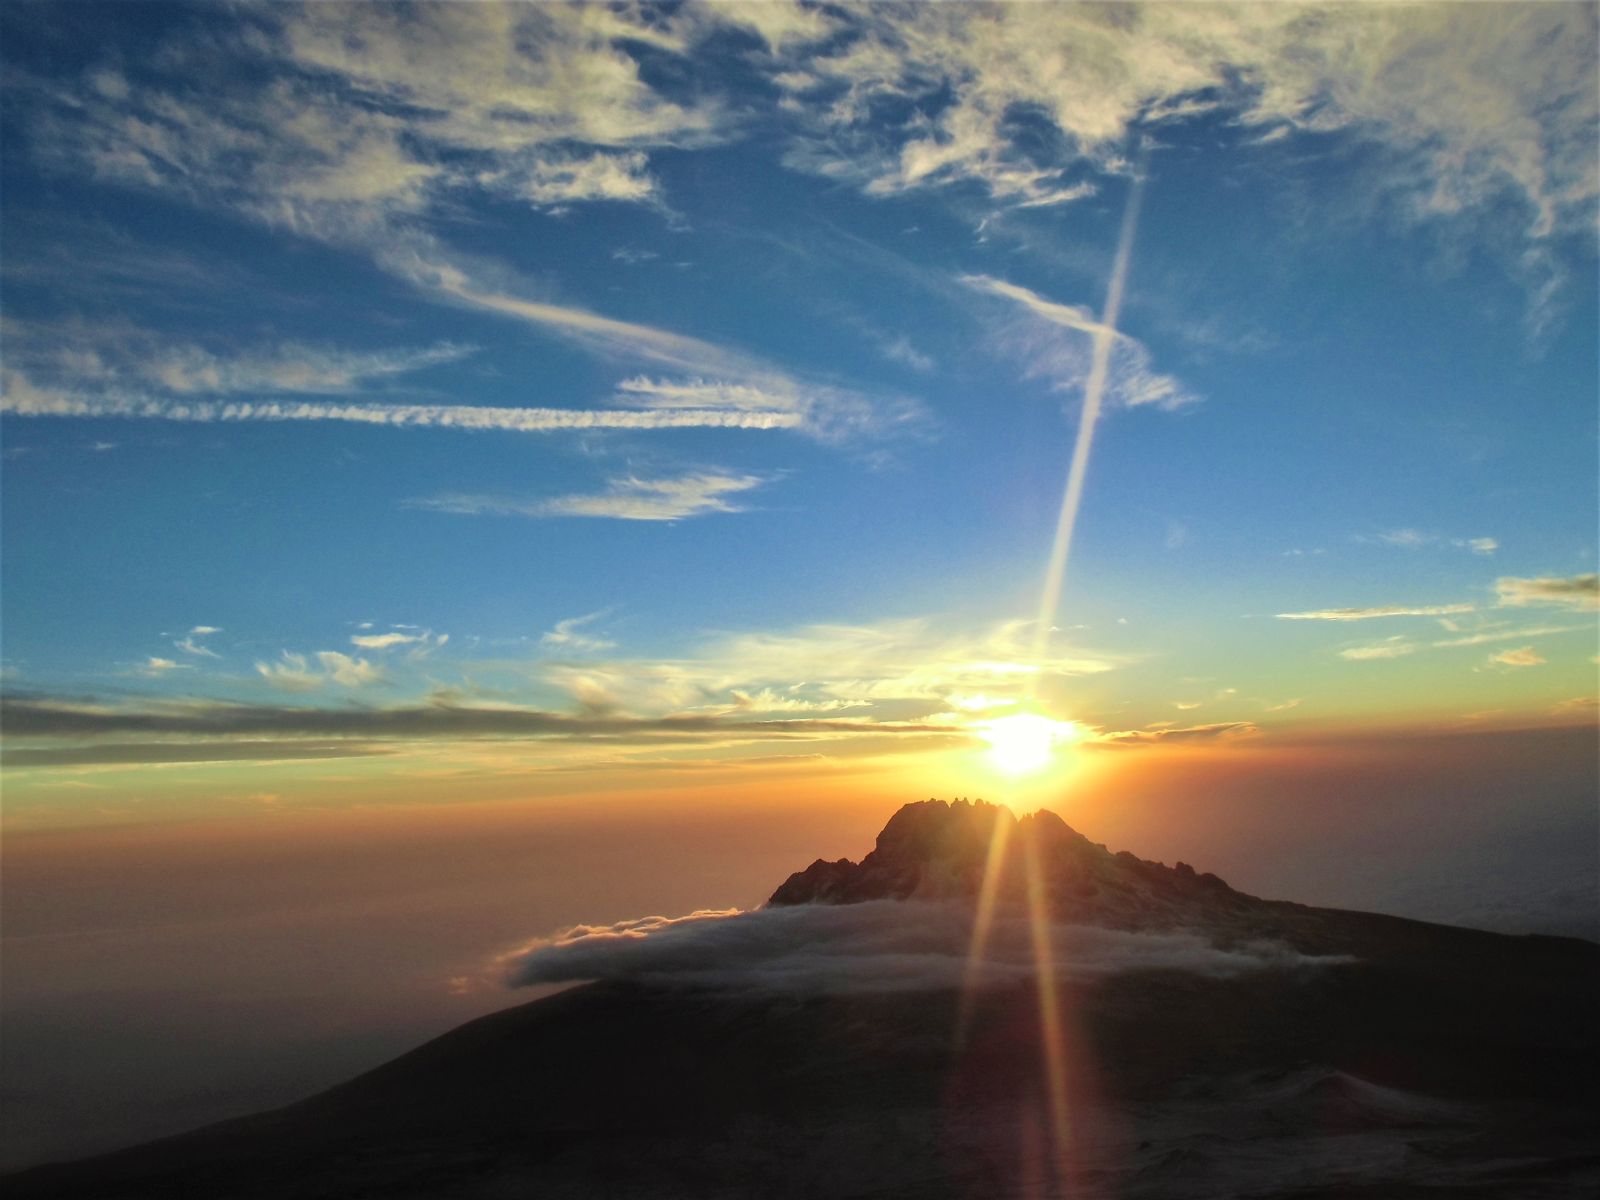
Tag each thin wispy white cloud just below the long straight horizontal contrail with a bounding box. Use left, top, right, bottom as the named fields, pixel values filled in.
left=406, top=470, right=768, bottom=522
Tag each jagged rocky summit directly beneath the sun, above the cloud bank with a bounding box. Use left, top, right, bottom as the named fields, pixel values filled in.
left=768, top=800, right=1248, bottom=928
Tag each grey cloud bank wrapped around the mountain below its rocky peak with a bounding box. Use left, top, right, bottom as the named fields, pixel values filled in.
left=501, top=901, right=1349, bottom=994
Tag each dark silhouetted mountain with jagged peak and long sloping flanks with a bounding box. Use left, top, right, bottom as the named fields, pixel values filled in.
left=12, top=802, right=1600, bottom=1200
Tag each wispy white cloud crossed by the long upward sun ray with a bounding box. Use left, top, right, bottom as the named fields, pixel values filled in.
left=962, top=275, right=1198, bottom=410
